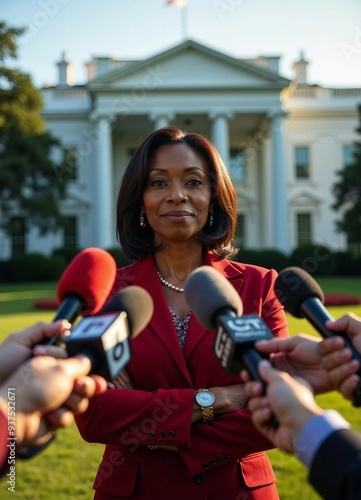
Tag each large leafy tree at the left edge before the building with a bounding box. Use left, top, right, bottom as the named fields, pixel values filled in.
left=0, top=22, right=74, bottom=234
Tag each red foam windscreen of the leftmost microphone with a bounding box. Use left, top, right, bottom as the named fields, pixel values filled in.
left=57, top=247, right=117, bottom=316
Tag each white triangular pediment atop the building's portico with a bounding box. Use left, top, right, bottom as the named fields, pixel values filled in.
left=88, top=40, right=289, bottom=91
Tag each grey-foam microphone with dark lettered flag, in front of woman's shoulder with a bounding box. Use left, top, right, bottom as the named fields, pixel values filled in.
left=184, top=266, right=273, bottom=391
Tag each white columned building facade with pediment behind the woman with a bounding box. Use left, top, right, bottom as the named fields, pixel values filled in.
left=0, top=41, right=361, bottom=259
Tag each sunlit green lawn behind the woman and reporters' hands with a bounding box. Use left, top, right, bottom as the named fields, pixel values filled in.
left=0, top=278, right=361, bottom=500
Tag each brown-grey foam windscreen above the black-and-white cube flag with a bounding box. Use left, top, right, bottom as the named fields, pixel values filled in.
left=100, top=285, right=154, bottom=338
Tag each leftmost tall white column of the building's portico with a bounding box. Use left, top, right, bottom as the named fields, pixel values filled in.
left=94, top=117, right=115, bottom=248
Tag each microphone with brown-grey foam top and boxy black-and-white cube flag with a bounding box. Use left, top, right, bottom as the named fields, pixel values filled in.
left=64, top=286, right=153, bottom=380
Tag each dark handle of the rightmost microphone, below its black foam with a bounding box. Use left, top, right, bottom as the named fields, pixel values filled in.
left=301, top=297, right=361, bottom=408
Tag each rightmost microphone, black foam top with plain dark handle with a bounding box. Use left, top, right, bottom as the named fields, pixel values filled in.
left=275, top=267, right=361, bottom=407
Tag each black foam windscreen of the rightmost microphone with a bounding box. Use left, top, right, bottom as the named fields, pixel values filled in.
left=275, top=267, right=324, bottom=318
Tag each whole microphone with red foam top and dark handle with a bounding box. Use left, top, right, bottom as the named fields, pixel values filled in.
left=41, top=247, right=117, bottom=345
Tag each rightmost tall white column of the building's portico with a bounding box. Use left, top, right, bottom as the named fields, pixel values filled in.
left=269, top=110, right=289, bottom=253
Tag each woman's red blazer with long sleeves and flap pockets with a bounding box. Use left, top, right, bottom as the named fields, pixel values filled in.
left=76, top=252, right=287, bottom=500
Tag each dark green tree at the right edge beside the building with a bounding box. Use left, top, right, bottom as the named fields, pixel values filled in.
left=332, top=105, right=361, bottom=252
